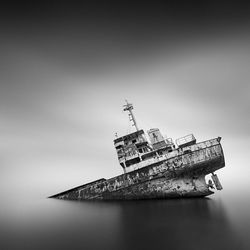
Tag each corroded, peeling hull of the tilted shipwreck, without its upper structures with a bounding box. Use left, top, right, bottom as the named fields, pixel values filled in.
left=50, top=138, right=225, bottom=200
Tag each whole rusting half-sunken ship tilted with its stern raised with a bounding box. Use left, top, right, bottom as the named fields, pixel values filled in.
left=50, top=101, right=225, bottom=200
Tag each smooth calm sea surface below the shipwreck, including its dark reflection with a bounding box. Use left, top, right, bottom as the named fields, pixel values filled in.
left=0, top=192, right=250, bottom=250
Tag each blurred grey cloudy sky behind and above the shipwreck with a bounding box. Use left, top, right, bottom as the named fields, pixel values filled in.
left=0, top=1, right=250, bottom=197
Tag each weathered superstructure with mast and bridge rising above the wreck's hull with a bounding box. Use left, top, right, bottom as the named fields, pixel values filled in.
left=114, top=100, right=196, bottom=173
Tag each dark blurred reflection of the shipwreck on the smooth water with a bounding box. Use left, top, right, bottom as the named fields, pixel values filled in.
left=116, top=198, right=243, bottom=250
